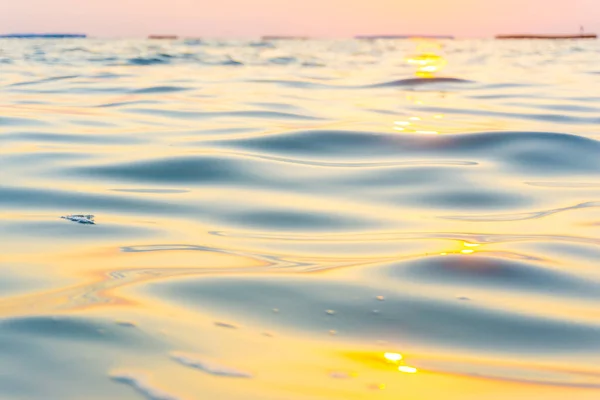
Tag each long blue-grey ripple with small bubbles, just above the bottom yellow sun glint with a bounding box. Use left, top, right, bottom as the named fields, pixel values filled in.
left=148, top=275, right=600, bottom=355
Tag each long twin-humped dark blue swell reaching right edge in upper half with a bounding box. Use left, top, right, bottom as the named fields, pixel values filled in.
left=212, top=130, right=600, bottom=174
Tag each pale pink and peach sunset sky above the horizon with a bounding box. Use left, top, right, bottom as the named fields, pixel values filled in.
left=0, top=0, right=600, bottom=37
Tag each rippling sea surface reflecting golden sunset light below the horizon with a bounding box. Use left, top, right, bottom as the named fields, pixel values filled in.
left=0, top=39, right=600, bottom=400
